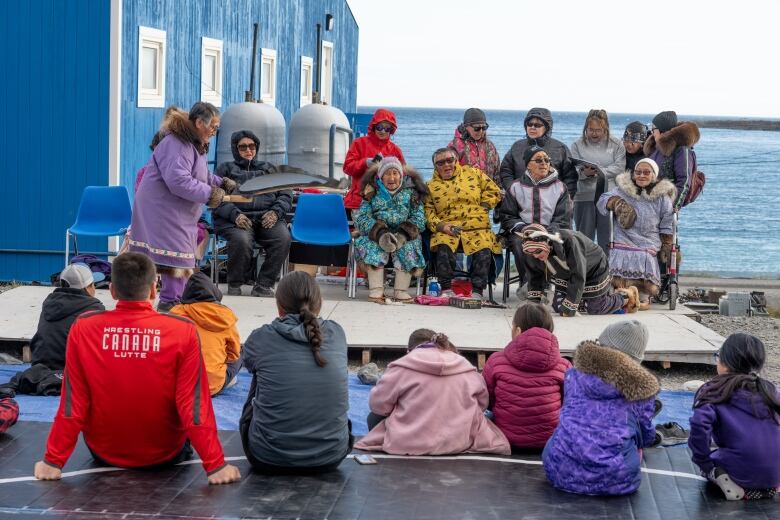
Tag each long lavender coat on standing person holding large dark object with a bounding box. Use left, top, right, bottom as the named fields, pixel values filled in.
left=129, top=134, right=222, bottom=268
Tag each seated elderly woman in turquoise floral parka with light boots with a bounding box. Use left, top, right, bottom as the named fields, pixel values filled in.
left=354, top=157, right=428, bottom=303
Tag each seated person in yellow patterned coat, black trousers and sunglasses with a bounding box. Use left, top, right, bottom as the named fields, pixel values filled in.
left=425, top=148, right=501, bottom=298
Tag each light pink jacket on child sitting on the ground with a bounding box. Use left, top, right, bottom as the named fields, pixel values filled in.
left=355, top=347, right=510, bottom=455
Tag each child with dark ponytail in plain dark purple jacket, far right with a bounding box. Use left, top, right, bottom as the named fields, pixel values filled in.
left=688, top=333, right=780, bottom=500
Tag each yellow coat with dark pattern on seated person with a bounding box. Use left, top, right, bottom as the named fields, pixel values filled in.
left=425, top=164, right=501, bottom=255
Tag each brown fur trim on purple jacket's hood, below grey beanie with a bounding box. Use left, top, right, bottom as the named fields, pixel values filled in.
left=574, top=341, right=660, bottom=401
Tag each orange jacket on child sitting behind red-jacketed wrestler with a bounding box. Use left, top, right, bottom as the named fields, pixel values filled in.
left=171, top=302, right=241, bottom=395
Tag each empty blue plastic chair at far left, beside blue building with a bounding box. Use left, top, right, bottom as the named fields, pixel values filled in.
left=65, top=186, right=133, bottom=267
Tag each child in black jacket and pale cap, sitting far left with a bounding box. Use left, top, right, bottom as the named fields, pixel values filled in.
left=30, top=264, right=105, bottom=370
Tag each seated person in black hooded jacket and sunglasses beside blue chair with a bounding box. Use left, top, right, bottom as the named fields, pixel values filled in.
left=214, top=130, right=292, bottom=296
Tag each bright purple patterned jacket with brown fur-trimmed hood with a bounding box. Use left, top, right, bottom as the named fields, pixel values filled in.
left=542, top=341, right=659, bottom=495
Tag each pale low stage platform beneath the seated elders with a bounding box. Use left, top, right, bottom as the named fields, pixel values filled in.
left=0, top=284, right=724, bottom=364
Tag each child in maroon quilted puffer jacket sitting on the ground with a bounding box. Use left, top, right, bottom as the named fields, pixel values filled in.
left=482, top=303, right=571, bottom=448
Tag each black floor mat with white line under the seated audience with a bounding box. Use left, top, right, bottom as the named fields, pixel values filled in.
left=0, top=422, right=780, bottom=520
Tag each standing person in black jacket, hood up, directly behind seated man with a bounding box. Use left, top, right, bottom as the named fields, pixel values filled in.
left=499, top=108, right=577, bottom=199
